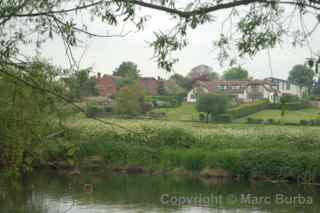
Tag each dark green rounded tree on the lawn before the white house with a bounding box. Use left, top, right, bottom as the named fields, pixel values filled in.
left=196, top=93, right=229, bottom=122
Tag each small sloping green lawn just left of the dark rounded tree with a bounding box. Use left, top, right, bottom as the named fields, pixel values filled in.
left=153, top=103, right=199, bottom=121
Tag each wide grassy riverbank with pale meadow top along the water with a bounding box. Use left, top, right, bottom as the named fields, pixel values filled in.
left=40, top=119, right=320, bottom=182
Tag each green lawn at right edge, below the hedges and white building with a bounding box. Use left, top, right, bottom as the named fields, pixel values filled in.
left=235, top=108, right=320, bottom=123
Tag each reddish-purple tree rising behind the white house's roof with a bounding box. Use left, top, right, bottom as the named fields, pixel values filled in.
left=188, top=64, right=219, bottom=82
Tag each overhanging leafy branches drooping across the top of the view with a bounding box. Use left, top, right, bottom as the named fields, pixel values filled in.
left=0, top=0, right=320, bottom=71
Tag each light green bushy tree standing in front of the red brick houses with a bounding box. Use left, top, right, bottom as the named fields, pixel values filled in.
left=115, top=81, right=145, bottom=115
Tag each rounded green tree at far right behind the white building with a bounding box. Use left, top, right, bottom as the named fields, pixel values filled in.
left=288, top=64, right=315, bottom=89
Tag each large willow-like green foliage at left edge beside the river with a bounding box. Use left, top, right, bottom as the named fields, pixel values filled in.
left=0, top=59, right=66, bottom=180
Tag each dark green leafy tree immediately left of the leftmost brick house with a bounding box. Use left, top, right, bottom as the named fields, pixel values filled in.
left=64, top=69, right=99, bottom=100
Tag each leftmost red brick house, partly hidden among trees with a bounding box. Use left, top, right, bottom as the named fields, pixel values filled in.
left=97, top=73, right=117, bottom=97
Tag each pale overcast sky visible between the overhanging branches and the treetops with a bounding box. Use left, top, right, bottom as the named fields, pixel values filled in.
left=28, top=6, right=320, bottom=79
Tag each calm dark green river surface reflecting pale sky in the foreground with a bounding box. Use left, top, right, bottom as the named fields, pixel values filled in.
left=0, top=172, right=320, bottom=213
